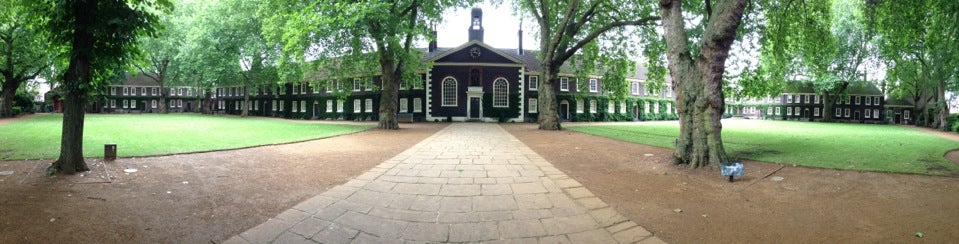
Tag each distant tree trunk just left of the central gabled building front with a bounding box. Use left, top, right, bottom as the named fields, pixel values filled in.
left=376, top=51, right=402, bottom=130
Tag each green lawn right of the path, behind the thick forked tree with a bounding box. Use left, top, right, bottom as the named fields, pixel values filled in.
left=567, top=120, right=959, bottom=175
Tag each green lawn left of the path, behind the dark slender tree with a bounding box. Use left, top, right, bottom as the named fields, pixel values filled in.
left=0, top=114, right=370, bottom=160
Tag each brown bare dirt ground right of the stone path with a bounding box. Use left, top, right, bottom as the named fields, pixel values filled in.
left=504, top=124, right=959, bottom=243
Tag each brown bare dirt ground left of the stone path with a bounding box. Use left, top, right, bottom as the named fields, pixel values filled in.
left=0, top=123, right=446, bottom=243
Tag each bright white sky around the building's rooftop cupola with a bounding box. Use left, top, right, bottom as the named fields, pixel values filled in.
left=436, top=1, right=539, bottom=49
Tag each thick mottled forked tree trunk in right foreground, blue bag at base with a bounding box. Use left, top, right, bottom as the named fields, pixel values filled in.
left=660, top=0, right=746, bottom=168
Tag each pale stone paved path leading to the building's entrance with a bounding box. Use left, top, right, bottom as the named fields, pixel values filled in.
left=226, top=123, right=662, bottom=243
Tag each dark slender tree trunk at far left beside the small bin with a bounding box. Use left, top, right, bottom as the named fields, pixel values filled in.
left=47, top=1, right=96, bottom=174
